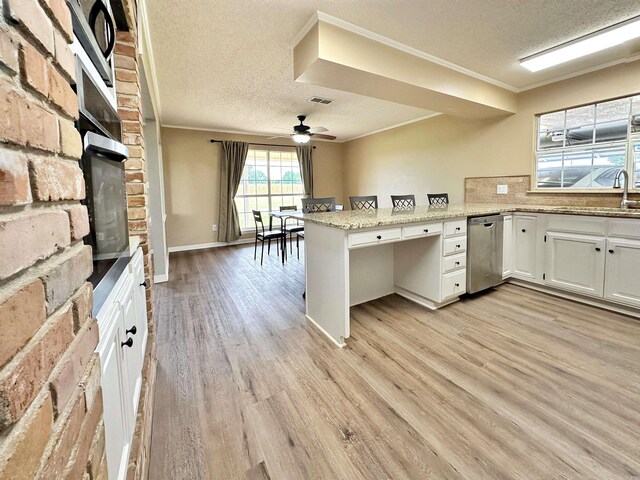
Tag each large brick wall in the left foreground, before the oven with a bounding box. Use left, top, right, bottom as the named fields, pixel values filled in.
left=0, top=0, right=106, bottom=479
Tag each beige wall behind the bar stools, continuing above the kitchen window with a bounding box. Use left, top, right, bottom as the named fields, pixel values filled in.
left=344, top=61, right=640, bottom=207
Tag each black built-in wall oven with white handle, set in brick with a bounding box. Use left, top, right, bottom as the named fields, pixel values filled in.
left=76, top=60, right=130, bottom=316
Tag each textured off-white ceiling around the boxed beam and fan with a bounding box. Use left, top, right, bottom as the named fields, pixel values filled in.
left=147, top=0, right=640, bottom=141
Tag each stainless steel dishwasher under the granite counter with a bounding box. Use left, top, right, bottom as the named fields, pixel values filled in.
left=467, top=215, right=504, bottom=293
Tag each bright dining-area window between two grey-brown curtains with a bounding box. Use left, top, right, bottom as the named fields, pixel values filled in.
left=235, top=149, right=304, bottom=231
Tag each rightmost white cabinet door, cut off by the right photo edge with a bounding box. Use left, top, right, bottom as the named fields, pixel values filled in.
left=604, top=238, right=640, bottom=307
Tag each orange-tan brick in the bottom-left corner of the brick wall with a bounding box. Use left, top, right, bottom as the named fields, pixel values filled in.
left=0, top=393, right=53, bottom=480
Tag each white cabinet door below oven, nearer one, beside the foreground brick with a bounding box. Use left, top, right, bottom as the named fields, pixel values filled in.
left=100, top=304, right=130, bottom=479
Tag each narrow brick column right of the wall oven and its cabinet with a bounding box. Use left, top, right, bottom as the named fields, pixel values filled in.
left=115, top=0, right=157, bottom=480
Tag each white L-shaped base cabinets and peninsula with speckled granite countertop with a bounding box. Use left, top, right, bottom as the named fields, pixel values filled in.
left=298, top=204, right=640, bottom=347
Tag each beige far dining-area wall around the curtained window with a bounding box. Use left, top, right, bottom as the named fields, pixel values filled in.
left=162, top=127, right=343, bottom=248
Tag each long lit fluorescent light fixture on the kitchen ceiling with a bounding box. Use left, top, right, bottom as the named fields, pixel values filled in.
left=520, top=17, right=640, bottom=72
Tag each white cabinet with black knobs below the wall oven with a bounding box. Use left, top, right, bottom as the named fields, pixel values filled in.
left=97, top=249, right=147, bottom=480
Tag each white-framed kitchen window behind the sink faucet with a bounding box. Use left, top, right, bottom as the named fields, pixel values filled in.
left=536, top=95, right=640, bottom=189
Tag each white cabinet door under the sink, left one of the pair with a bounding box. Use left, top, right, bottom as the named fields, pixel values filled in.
left=545, top=232, right=606, bottom=297
